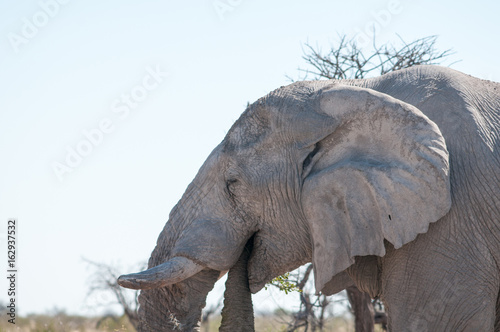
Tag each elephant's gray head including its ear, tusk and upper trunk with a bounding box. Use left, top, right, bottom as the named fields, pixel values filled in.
left=119, top=81, right=451, bottom=331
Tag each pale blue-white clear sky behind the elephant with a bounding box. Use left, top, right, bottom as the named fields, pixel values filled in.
left=0, top=0, right=500, bottom=314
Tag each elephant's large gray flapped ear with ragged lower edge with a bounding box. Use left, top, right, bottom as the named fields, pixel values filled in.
left=302, top=85, right=451, bottom=292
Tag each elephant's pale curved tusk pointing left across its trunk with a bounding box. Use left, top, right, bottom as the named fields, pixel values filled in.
left=118, top=257, right=204, bottom=289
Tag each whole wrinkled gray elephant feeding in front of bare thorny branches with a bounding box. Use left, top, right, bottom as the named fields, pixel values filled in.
left=120, top=66, right=500, bottom=331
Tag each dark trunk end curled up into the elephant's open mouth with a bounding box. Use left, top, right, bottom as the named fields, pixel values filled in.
left=219, top=239, right=255, bottom=332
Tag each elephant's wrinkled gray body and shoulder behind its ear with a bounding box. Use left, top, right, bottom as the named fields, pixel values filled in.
left=354, top=67, right=500, bottom=331
